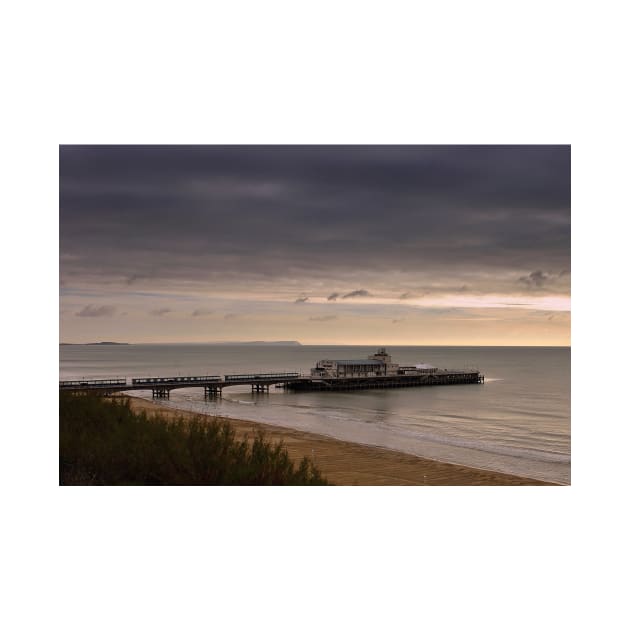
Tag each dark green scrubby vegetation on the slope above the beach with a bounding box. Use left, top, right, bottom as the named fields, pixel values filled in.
left=59, top=392, right=327, bottom=485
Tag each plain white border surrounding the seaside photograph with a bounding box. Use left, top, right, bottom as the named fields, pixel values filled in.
left=2, top=2, right=628, bottom=628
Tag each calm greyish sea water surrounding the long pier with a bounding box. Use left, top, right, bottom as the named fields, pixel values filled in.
left=60, top=344, right=571, bottom=483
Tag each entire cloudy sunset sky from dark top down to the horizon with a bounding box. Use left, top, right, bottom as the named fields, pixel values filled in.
left=59, top=145, right=571, bottom=346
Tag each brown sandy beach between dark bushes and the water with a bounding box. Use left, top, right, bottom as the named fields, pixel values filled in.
left=123, top=395, right=562, bottom=486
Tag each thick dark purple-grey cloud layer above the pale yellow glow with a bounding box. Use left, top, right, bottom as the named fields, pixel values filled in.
left=59, top=145, right=570, bottom=301
